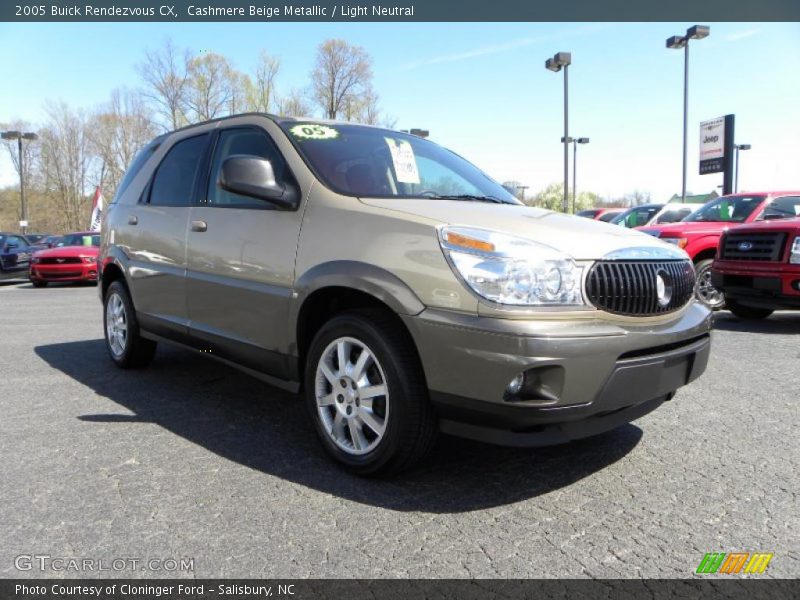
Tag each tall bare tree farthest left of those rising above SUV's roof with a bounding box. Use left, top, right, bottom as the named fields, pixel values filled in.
left=138, top=38, right=191, bottom=129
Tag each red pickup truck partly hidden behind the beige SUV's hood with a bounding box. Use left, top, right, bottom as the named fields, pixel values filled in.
left=640, top=191, right=800, bottom=309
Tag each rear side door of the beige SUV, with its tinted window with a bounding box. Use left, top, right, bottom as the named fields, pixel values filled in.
left=122, top=131, right=212, bottom=340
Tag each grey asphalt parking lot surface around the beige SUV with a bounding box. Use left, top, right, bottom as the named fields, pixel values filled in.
left=0, top=283, right=800, bottom=578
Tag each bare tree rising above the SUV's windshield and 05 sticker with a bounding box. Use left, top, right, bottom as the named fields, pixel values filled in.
left=312, top=40, right=372, bottom=119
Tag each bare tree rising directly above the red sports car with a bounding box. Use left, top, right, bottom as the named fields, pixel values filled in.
left=40, top=102, right=95, bottom=230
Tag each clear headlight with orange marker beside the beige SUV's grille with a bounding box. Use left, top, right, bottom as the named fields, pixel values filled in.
left=439, top=227, right=584, bottom=306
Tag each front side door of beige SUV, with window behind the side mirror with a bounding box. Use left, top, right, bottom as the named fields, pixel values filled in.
left=186, top=118, right=302, bottom=377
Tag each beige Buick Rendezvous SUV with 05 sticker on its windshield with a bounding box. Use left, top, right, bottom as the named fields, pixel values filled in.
left=99, top=114, right=710, bottom=474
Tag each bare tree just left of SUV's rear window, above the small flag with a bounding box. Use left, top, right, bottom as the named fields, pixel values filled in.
left=89, top=88, right=156, bottom=196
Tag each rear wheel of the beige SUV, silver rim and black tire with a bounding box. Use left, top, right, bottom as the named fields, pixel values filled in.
left=103, top=281, right=156, bottom=369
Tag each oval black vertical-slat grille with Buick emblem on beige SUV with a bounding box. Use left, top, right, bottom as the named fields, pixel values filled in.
left=586, top=260, right=694, bottom=316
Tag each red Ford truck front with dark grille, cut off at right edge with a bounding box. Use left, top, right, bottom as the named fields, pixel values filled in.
left=711, top=216, right=800, bottom=319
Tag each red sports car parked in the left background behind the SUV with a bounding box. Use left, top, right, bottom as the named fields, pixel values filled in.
left=28, top=231, right=100, bottom=287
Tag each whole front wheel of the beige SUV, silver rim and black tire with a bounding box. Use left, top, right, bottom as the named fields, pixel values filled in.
left=305, top=311, right=438, bottom=476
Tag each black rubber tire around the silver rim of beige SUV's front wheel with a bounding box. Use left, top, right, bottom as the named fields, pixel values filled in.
left=304, top=310, right=438, bottom=476
